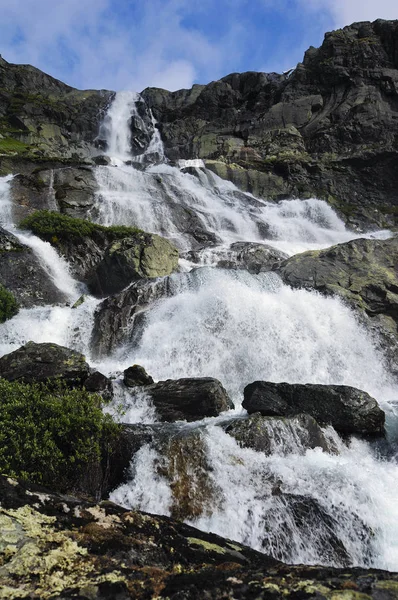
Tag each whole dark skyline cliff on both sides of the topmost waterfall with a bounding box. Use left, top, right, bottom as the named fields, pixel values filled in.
left=0, top=20, right=398, bottom=227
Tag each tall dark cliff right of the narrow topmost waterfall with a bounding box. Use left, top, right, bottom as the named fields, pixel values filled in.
left=143, top=20, right=398, bottom=225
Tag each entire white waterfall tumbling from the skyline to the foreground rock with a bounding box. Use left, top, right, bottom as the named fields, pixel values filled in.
left=0, top=92, right=398, bottom=570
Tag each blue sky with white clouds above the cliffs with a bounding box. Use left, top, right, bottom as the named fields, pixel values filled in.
left=0, top=0, right=398, bottom=91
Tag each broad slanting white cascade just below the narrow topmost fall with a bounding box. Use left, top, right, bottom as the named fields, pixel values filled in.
left=92, top=164, right=390, bottom=255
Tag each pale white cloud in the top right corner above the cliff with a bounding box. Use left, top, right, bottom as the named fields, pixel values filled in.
left=300, top=0, right=398, bottom=27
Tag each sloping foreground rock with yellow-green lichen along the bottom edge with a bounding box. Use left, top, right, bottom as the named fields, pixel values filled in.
left=0, top=476, right=398, bottom=600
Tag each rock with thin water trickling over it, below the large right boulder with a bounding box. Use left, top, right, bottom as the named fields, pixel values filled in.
left=221, top=413, right=336, bottom=455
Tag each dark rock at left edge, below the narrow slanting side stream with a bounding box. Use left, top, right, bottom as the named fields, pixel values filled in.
left=0, top=227, right=67, bottom=308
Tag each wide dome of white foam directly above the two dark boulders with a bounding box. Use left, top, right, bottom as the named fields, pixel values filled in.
left=112, top=268, right=397, bottom=403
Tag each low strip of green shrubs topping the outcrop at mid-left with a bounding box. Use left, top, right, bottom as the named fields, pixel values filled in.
left=20, top=210, right=143, bottom=243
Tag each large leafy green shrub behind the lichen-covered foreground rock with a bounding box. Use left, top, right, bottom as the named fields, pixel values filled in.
left=0, top=379, right=119, bottom=491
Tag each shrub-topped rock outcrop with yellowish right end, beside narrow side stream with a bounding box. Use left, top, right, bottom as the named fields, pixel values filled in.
left=21, top=210, right=178, bottom=296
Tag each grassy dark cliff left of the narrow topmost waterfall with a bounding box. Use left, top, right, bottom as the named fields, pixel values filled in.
left=0, top=57, right=113, bottom=166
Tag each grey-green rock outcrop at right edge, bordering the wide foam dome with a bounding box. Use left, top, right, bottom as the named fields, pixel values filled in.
left=276, top=236, right=398, bottom=371
